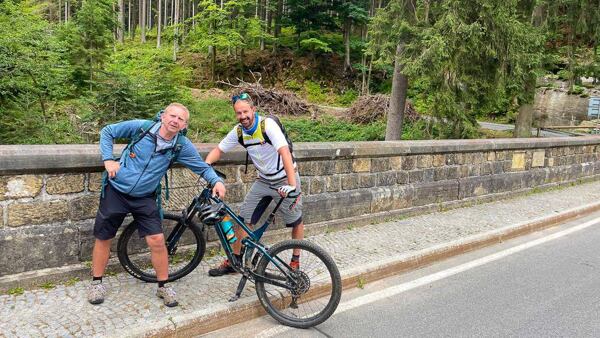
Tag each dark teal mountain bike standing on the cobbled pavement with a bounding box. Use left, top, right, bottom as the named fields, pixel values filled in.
left=117, top=171, right=342, bottom=328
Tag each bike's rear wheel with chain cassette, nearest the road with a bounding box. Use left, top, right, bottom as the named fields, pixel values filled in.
left=256, top=240, right=342, bottom=328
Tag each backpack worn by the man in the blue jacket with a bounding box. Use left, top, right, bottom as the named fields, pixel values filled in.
left=101, top=110, right=187, bottom=218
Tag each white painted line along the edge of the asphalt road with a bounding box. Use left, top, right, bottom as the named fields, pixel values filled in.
left=256, top=218, right=600, bottom=338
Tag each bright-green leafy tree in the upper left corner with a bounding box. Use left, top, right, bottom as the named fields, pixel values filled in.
left=0, top=0, right=71, bottom=115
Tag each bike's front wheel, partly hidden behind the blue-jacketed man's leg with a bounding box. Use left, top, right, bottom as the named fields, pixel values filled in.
left=117, top=213, right=206, bottom=283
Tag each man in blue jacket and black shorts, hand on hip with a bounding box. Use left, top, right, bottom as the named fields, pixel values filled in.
left=88, top=103, right=225, bottom=307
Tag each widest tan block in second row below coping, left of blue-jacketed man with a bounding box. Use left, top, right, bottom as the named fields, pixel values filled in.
left=8, top=200, right=69, bottom=227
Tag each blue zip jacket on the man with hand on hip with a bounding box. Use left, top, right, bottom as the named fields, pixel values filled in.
left=100, top=120, right=222, bottom=197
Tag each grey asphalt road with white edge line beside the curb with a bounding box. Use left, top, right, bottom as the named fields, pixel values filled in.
left=205, top=214, right=600, bottom=337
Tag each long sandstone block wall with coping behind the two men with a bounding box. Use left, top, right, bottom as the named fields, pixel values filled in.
left=0, top=137, right=600, bottom=276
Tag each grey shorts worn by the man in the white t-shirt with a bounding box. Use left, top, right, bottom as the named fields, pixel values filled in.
left=240, top=173, right=302, bottom=227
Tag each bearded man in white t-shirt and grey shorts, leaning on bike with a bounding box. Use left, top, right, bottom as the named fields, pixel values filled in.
left=206, top=93, right=304, bottom=277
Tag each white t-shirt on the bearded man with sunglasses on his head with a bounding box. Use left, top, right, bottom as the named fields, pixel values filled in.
left=219, top=115, right=296, bottom=180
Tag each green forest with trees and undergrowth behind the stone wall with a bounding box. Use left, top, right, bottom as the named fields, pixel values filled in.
left=0, top=0, right=600, bottom=144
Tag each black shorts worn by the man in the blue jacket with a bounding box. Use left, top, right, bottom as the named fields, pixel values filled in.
left=94, top=183, right=163, bottom=240
